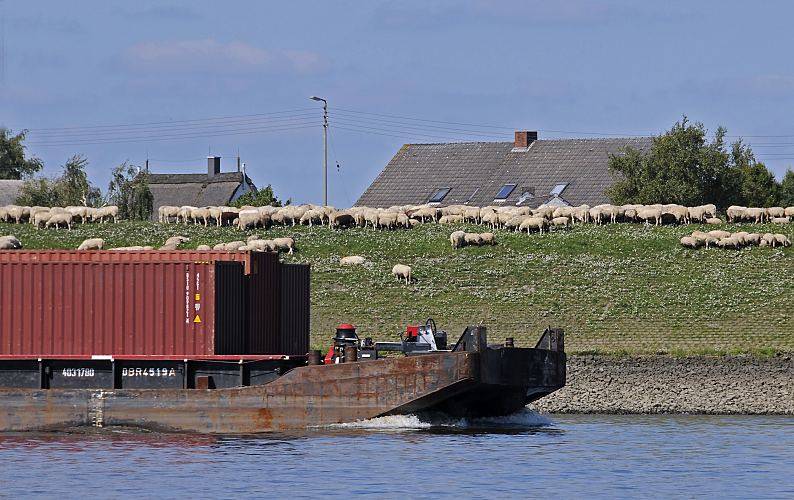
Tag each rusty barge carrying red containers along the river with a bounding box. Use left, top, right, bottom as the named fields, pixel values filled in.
left=0, top=252, right=565, bottom=434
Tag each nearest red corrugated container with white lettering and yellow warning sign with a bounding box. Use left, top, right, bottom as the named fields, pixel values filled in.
left=0, top=262, right=244, bottom=356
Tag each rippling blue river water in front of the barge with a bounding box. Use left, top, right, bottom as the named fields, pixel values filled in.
left=0, top=411, right=794, bottom=500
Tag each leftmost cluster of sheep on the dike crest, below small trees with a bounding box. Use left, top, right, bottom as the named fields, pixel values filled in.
left=0, top=205, right=119, bottom=229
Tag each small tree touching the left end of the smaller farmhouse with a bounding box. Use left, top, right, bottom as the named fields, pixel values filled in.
left=107, top=161, right=154, bottom=220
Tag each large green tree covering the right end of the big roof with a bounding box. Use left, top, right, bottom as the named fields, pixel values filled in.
left=607, top=116, right=765, bottom=209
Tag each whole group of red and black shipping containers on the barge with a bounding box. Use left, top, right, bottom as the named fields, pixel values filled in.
left=0, top=251, right=309, bottom=356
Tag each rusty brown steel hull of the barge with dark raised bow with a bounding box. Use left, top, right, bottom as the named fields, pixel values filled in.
left=0, top=349, right=565, bottom=434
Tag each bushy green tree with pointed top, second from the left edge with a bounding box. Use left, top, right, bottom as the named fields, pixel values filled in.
left=16, top=155, right=102, bottom=207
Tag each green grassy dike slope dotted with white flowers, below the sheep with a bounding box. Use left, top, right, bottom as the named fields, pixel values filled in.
left=0, top=222, right=794, bottom=354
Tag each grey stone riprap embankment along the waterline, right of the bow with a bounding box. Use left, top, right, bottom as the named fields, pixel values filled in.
left=531, top=355, right=794, bottom=415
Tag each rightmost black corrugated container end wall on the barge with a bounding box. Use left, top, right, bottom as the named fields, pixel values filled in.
left=280, top=264, right=311, bottom=354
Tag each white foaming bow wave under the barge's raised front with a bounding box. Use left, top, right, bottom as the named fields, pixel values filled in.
left=333, top=408, right=552, bottom=430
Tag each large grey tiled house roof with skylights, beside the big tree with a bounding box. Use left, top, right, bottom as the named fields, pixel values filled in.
left=356, top=137, right=651, bottom=207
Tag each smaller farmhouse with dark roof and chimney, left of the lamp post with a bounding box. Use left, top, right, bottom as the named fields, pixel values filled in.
left=149, top=156, right=256, bottom=218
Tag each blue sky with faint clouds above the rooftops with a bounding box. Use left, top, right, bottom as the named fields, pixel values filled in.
left=0, top=0, right=794, bottom=207
